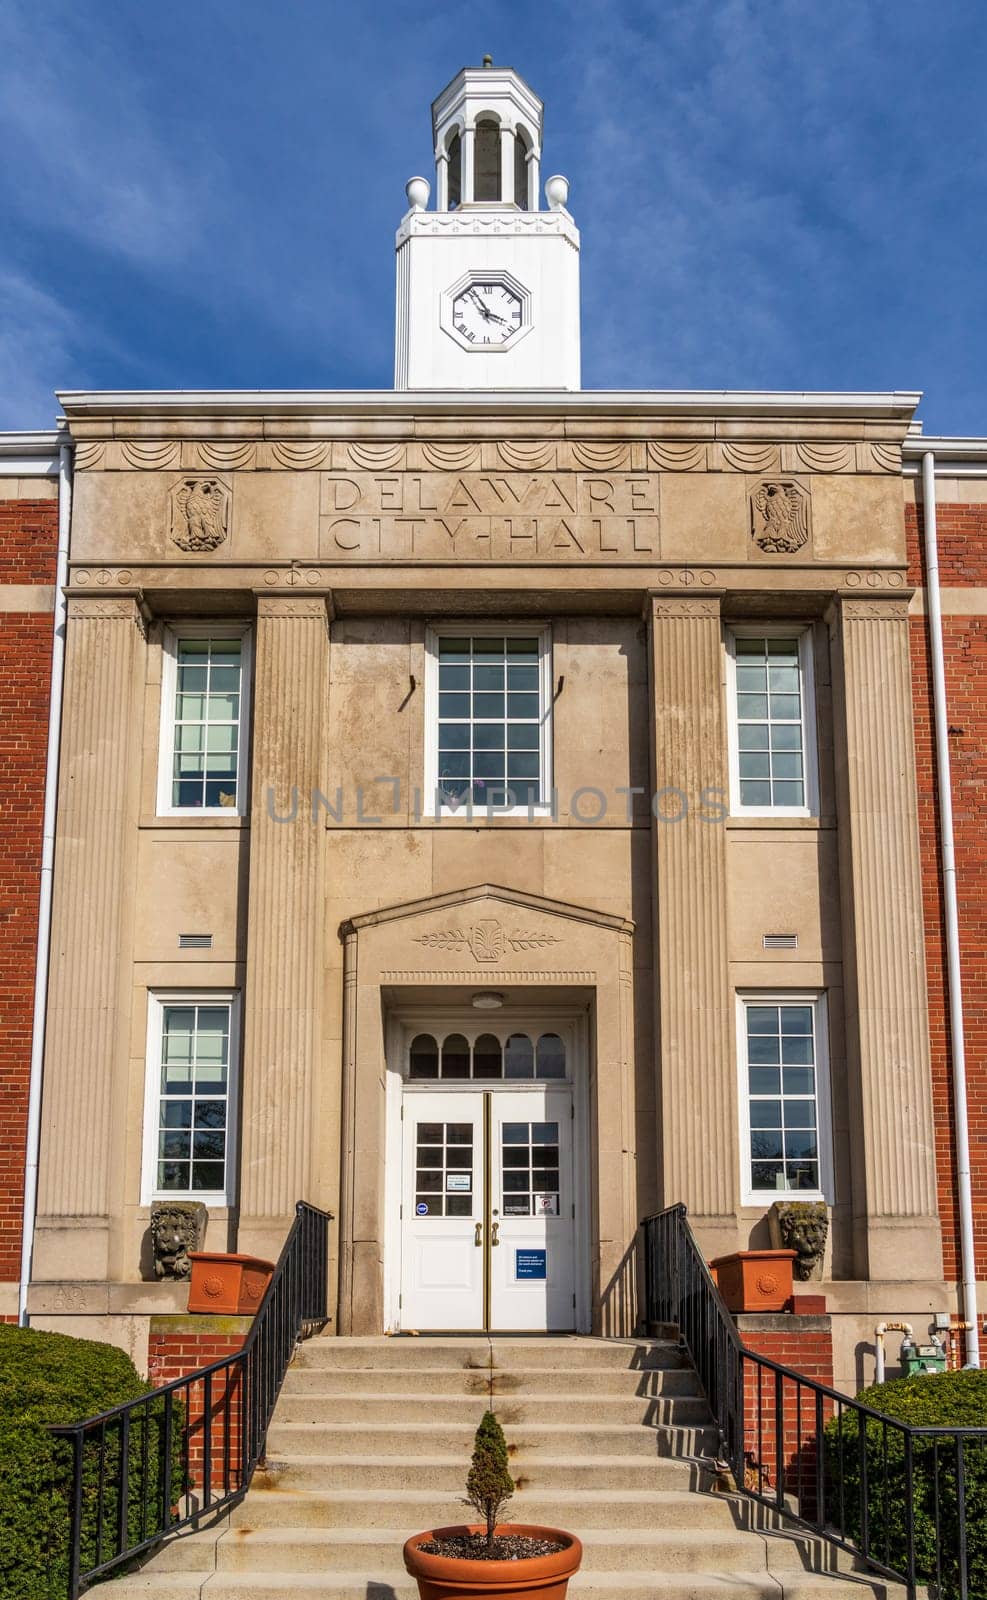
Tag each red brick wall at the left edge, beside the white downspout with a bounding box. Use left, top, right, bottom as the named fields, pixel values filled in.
left=0, top=499, right=58, bottom=1283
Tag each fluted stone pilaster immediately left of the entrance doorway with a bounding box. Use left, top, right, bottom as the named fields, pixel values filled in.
left=238, top=592, right=330, bottom=1259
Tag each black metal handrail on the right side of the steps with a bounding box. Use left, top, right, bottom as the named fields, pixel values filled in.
left=641, top=1205, right=987, bottom=1600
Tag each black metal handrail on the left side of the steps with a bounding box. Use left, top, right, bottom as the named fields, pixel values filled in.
left=51, top=1202, right=331, bottom=1600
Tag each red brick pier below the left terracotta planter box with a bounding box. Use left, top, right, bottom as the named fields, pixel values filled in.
left=147, top=1317, right=253, bottom=1491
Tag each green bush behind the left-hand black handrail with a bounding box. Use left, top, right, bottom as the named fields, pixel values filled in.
left=0, top=1326, right=182, bottom=1600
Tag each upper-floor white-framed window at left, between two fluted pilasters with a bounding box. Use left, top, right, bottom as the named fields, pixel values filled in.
left=158, top=622, right=250, bottom=816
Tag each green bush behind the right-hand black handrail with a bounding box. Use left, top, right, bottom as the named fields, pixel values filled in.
left=825, top=1371, right=987, bottom=1600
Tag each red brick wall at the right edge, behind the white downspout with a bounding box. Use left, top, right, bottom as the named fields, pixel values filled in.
left=907, top=504, right=987, bottom=1278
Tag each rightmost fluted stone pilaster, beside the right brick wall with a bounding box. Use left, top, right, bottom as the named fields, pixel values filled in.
left=832, top=597, right=942, bottom=1278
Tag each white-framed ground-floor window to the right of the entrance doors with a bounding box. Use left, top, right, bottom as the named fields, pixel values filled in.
left=737, top=995, right=832, bottom=1202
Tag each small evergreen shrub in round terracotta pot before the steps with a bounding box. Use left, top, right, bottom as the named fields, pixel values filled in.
left=405, top=1411, right=582, bottom=1600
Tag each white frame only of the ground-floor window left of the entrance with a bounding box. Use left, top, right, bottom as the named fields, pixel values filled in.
left=141, top=989, right=240, bottom=1206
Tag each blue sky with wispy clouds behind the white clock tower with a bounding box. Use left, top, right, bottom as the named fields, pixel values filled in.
left=0, top=0, right=987, bottom=434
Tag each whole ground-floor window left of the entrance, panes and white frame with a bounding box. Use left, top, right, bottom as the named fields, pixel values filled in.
left=144, top=994, right=237, bottom=1205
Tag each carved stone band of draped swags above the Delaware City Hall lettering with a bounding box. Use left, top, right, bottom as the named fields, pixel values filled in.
left=75, top=437, right=901, bottom=477
